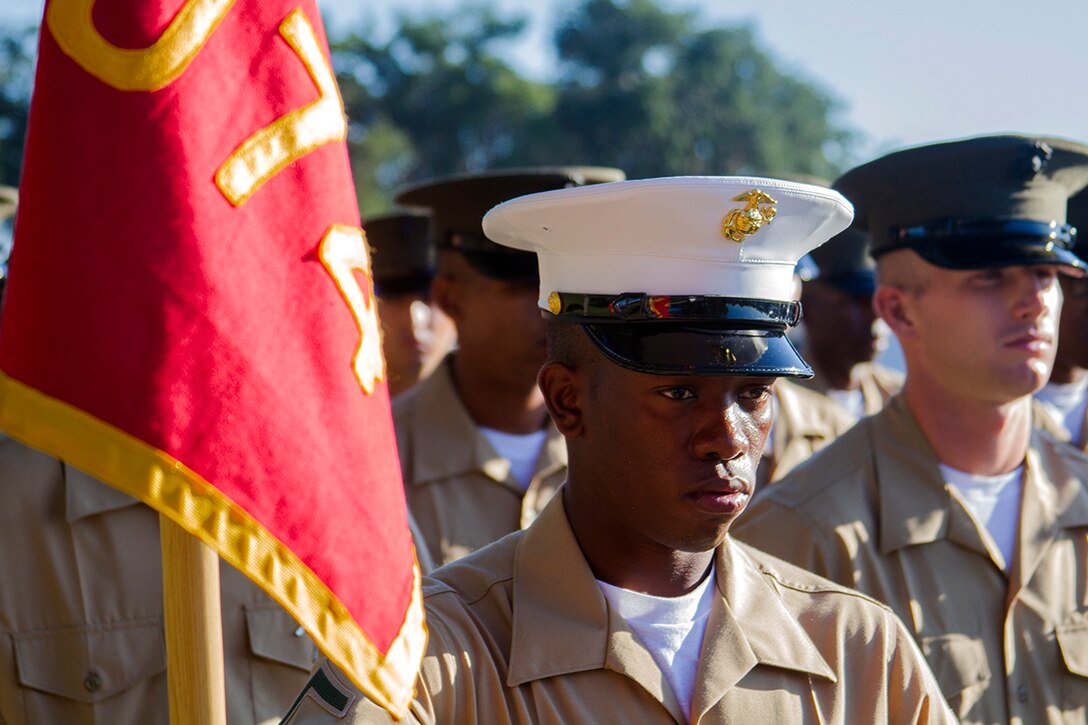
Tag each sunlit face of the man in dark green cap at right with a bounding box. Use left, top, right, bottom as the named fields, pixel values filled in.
left=893, top=262, right=1062, bottom=404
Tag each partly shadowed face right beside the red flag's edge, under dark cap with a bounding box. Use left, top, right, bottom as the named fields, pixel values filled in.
left=378, top=293, right=456, bottom=395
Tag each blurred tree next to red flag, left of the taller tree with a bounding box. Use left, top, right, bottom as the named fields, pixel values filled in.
left=333, top=5, right=555, bottom=214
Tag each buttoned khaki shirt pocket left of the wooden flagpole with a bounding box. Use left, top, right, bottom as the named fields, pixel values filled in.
left=12, top=619, right=166, bottom=722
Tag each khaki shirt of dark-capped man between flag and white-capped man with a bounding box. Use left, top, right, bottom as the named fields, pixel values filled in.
left=393, top=358, right=567, bottom=566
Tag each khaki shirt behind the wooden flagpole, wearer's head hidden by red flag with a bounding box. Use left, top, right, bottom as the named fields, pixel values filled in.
left=0, top=435, right=317, bottom=725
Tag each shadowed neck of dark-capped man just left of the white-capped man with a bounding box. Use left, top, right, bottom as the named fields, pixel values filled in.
left=450, top=356, right=547, bottom=434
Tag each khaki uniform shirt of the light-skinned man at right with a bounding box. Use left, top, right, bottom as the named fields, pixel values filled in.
left=734, top=397, right=1088, bottom=725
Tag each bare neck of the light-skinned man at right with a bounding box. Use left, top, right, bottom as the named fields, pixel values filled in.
left=903, top=376, right=1031, bottom=476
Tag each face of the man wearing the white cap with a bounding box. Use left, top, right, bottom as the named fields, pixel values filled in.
left=571, top=361, right=774, bottom=552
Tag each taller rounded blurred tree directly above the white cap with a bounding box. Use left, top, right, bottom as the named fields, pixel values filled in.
left=556, top=0, right=852, bottom=177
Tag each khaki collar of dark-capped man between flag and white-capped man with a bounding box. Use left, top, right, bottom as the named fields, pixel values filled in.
left=409, top=357, right=567, bottom=491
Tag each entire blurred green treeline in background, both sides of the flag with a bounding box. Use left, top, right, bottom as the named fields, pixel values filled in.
left=0, top=0, right=856, bottom=217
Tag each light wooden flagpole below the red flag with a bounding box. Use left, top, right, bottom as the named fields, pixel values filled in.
left=159, top=514, right=226, bottom=725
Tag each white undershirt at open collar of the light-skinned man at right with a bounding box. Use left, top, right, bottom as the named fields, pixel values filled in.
left=940, top=464, right=1024, bottom=572
